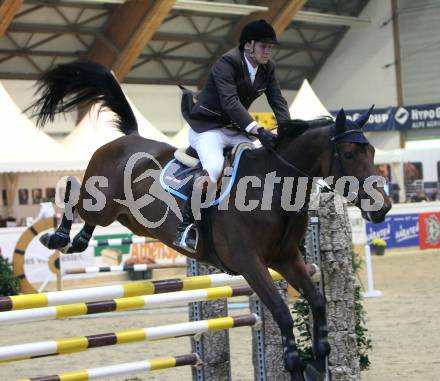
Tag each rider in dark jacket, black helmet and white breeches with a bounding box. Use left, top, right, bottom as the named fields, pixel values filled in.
left=173, top=20, right=290, bottom=252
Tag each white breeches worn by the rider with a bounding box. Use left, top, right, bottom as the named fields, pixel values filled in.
left=189, top=128, right=252, bottom=183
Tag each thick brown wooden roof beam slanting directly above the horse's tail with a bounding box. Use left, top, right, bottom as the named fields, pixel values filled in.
left=88, top=0, right=176, bottom=81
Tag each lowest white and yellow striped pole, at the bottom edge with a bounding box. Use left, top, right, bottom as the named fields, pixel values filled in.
left=19, top=353, right=201, bottom=381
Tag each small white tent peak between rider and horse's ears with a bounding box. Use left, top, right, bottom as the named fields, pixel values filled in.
left=289, top=79, right=331, bottom=120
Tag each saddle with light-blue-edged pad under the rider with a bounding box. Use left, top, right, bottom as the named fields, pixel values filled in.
left=160, top=143, right=254, bottom=206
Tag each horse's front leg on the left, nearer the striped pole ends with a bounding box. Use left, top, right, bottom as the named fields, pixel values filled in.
left=240, top=259, right=304, bottom=381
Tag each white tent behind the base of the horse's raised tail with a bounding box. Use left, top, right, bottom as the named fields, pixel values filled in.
left=63, top=98, right=171, bottom=160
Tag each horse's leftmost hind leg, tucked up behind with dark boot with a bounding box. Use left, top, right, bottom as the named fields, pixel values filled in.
left=40, top=177, right=79, bottom=250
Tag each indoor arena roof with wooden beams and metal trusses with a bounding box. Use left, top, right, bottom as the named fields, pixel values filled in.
left=0, top=0, right=369, bottom=89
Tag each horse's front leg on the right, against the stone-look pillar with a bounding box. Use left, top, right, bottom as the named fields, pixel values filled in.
left=272, top=250, right=330, bottom=381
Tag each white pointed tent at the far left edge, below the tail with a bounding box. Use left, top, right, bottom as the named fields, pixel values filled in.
left=0, top=83, right=85, bottom=173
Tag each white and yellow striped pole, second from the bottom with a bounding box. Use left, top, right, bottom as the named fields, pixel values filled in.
left=0, top=314, right=259, bottom=363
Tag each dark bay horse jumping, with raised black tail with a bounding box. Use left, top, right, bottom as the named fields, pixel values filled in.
left=31, top=61, right=391, bottom=381
